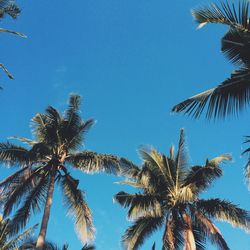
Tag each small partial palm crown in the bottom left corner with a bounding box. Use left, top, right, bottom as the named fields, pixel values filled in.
left=0, top=216, right=37, bottom=250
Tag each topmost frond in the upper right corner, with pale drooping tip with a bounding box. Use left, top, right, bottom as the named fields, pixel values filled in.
left=192, top=0, right=249, bottom=31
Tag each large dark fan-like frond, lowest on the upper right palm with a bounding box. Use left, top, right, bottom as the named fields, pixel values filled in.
left=172, top=68, right=250, bottom=119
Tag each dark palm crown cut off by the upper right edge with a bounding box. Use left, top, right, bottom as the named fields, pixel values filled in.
left=172, top=0, right=250, bottom=119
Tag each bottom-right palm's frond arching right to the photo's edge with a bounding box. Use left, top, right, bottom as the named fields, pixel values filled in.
left=196, top=199, right=250, bottom=230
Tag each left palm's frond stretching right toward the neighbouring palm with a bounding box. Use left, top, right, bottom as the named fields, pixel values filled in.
left=66, top=151, right=120, bottom=174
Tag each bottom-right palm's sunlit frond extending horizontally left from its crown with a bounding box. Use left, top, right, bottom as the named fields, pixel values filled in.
left=114, top=192, right=162, bottom=220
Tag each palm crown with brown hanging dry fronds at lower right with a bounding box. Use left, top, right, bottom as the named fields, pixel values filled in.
left=114, top=130, right=250, bottom=250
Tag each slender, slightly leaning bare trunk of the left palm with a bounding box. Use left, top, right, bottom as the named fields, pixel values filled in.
left=36, top=171, right=55, bottom=250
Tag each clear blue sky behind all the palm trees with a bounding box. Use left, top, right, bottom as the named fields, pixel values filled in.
left=0, top=0, right=250, bottom=250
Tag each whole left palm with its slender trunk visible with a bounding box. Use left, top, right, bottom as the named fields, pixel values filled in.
left=0, top=95, right=120, bottom=249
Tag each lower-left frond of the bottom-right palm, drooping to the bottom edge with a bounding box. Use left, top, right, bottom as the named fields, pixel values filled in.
left=122, top=217, right=163, bottom=250
